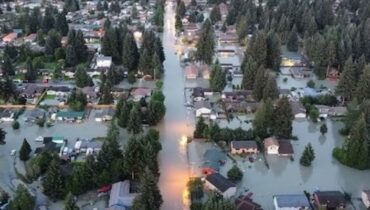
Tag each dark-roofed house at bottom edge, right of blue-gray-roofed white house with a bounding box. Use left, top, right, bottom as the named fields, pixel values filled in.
left=313, top=191, right=346, bottom=210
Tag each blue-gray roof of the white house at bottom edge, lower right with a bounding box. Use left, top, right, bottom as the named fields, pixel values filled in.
left=274, top=194, right=310, bottom=208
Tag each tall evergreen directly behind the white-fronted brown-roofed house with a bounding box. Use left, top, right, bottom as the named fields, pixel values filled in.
left=272, top=97, right=294, bottom=138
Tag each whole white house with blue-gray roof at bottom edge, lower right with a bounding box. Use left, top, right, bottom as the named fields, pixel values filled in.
left=273, top=194, right=311, bottom=210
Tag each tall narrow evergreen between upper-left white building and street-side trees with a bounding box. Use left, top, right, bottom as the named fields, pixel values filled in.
left=122, top=33, right=140, bottom=72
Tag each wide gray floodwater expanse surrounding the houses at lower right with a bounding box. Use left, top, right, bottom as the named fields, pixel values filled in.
left=221, top=120, right=370, bottom=210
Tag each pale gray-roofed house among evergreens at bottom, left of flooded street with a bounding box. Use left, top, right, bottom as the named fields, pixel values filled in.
left=106, top=180, right=137, bottom=210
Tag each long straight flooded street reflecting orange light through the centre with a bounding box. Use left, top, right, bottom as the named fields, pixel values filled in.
left=158, top=2, right=193, bottom=210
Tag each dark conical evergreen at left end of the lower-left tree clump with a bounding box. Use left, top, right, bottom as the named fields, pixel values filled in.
left=42, top=157, right=65, bottom=200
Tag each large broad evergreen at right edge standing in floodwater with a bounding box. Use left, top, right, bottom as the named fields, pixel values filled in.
left=344, top=115, right=369, bottom=169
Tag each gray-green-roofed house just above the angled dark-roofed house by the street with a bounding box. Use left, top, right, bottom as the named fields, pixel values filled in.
left=202, top=149, right=226, bottom=175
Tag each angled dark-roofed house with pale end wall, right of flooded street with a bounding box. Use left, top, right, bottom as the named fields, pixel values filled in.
left=204, top=173, right=236, bottom=198
